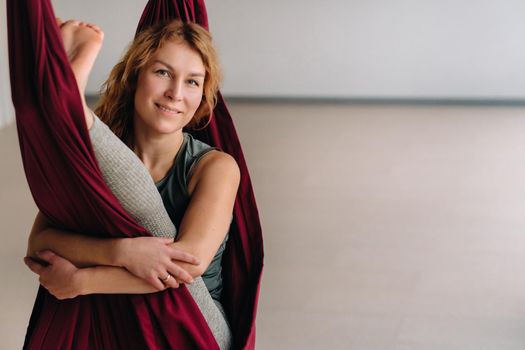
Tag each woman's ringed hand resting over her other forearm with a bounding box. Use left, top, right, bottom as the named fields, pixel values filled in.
left=116, top=237, right=200, bottom=290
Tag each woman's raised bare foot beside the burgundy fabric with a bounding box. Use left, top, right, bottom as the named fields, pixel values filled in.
left=57, top=19, right=104, bottom=96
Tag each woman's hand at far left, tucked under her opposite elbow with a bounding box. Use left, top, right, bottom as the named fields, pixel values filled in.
left=24, top=250, right=82, bottom=300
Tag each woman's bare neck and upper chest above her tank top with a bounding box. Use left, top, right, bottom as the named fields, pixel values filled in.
left=133, top=131, right=184, bottom=182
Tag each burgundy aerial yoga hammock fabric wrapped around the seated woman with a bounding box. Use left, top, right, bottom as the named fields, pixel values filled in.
left=7, top=0, right=263, bottom=349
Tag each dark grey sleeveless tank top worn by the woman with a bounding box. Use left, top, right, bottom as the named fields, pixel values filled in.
left=156, top=133, right=228, bottom=301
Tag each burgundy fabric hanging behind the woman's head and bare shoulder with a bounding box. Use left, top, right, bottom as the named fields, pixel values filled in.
left=137, top=0, right=264, bottom=349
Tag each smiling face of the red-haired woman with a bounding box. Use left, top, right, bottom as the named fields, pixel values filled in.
left=134, top=42, right=206, bottom=135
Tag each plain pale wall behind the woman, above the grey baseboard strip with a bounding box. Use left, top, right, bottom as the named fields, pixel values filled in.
left=7, top=0, right=525, bottom=98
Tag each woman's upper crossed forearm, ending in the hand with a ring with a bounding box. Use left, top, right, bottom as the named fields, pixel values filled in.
left=27, top=213, right=199, bottom=293
